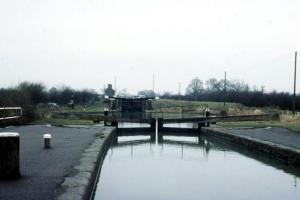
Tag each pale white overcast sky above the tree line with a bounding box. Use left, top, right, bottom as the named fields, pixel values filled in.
left=0, top=0, right=300, bottom=92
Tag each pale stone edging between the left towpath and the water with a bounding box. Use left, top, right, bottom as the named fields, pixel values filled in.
left=55, top=127, right=116, bottom=200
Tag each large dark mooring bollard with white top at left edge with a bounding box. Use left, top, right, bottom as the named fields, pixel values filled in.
left=0, top=132, right=20, bottom=179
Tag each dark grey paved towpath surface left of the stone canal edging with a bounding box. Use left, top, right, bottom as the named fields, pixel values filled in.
left=0, top=125, right=103, bottom=200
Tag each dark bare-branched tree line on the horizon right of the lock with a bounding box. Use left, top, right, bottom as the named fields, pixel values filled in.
left=161, top=78, right=300, bottom=110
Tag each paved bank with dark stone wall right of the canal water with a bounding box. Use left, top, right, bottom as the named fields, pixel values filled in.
left=202, top=127, right=300, bottom=166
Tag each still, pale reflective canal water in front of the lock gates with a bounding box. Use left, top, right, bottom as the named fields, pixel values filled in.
left=94, top=129, right=300, bottom=200
